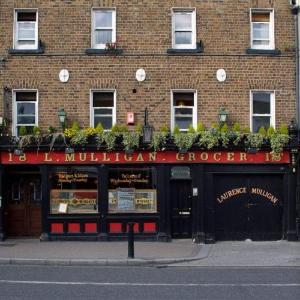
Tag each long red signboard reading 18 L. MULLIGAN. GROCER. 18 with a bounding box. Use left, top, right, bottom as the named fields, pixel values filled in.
left=1, top=151, right=290, bottom=165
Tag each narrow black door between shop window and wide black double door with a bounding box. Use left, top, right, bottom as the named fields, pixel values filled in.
left=171, top=180, right=192, bottom=238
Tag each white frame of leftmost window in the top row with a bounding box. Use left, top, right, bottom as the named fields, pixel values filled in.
left=13, top=8, right=39, bottom=50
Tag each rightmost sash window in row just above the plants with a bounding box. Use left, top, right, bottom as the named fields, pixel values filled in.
left=250, top=91, right=275, bottom=132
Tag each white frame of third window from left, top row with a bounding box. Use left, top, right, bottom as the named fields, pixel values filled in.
left=172, top=7, right=197, bottom=49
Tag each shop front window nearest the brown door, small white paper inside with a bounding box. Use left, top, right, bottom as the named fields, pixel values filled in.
left=50, top=167, right=98, bottom=214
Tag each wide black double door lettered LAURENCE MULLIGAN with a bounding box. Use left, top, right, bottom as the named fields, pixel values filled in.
left=214, top=174, right=283, bottom=240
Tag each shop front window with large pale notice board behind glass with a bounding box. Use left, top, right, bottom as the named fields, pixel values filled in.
left=108, top=168, right=157, bottom=213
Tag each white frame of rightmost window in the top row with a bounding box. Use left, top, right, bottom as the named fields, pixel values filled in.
left=250, top=8, right=275, bottom=50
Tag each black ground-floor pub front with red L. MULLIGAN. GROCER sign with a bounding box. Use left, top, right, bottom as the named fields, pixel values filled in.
left=1, top=151, right=296, bottom=243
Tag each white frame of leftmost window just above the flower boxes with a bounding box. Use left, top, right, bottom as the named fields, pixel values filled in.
left=12, top=89, right=39, bottom=136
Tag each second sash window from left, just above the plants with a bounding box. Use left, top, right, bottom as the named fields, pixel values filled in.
left=91, top=91, right=116, bottom=130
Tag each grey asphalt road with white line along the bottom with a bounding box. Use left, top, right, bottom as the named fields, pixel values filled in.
left=0, top=265, right=300, bottom=300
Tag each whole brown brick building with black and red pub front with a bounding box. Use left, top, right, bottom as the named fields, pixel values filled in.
left=0, top=0, right=297, bottom=242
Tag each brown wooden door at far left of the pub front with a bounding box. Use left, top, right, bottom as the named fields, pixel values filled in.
left=5, top=175, right=41, bottom=237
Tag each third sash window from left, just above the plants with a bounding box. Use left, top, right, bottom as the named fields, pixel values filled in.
left=171, top=91, right=197, bottom=131
